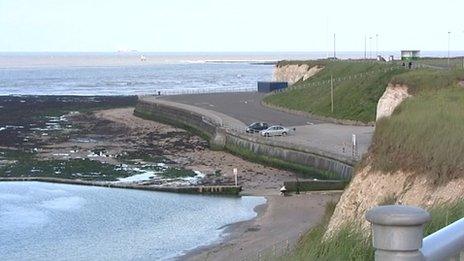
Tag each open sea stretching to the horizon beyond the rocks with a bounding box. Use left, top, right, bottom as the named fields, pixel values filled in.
left=0, top=51, right=464, bottom=95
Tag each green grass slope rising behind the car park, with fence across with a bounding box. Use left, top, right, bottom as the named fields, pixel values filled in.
left=264, top=60, right=405, bottom=123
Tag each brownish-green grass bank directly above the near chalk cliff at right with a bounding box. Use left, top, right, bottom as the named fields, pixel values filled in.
left=365, top=84, right=464, bottom=179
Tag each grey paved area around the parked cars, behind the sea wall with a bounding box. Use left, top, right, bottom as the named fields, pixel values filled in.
left=160, top=93, right=374, bottom=157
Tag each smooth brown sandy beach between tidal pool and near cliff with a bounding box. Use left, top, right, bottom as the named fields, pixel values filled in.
left=181, top=192, right=341, bottom=260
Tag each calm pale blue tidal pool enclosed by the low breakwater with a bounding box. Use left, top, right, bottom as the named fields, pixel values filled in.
left=0, top=182, right=265, bottom=260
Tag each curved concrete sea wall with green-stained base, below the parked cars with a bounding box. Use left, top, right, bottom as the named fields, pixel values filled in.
left=134, top=98, right=355, bottom=180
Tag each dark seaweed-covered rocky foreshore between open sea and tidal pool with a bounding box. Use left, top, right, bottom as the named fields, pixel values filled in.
left=0, top=96, right=295, bottom=195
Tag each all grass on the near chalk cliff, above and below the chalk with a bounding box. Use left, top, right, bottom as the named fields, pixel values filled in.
left=266, top=64, right=464, bottom=260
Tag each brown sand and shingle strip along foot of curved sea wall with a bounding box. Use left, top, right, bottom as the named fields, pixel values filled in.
left=95, top=108, right=301, bottom=195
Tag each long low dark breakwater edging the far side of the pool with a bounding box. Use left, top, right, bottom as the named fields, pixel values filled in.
left=0, top=177, right=242, bottom=195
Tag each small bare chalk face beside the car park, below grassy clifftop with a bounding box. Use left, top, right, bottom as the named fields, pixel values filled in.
left=376, top=84, right=410, bottom=120
